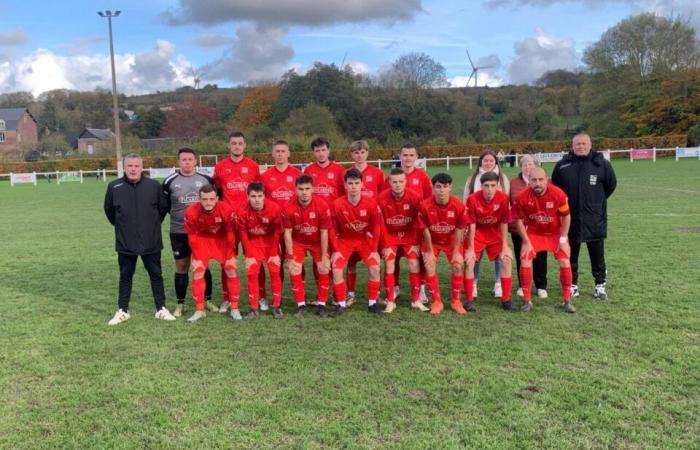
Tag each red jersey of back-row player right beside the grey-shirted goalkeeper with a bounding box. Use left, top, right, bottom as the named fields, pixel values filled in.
left=214, top=156, right=260, bottom=210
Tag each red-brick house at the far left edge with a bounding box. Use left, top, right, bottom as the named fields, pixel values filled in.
left=0, top=108, right=39, bottom=159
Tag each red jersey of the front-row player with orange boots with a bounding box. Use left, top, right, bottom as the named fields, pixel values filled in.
left=418, top=195, right=468, bottom=247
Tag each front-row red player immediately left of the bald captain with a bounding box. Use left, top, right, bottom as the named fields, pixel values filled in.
left=464, top=172, right=517, bottom=312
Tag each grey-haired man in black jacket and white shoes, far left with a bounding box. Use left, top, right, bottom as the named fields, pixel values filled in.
left=104, top=153, right=175, bottom=325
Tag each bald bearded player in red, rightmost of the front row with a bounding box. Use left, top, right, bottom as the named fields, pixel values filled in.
left=513, top=167, right=576, bottom=313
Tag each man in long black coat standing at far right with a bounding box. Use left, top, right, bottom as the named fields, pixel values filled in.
left=552, top=133, right=617, bottom=300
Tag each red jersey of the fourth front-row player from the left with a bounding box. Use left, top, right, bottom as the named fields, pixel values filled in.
left=330, top=197, right=381, bottom=251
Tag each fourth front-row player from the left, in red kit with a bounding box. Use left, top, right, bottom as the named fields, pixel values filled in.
left=329, top=169, right=383, bottom=316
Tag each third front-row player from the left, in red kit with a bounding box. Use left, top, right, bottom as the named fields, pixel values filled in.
left=282, top=175, right=332, bottom=318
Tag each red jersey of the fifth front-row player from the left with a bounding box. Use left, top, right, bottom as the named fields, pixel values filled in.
left=378, top=189, right=421, bottom=247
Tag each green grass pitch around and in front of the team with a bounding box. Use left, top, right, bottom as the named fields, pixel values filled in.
left=0, top=160, right=700, bottom=449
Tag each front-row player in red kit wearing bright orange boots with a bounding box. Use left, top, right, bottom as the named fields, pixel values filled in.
left=418, top=173, right=467, bottom=315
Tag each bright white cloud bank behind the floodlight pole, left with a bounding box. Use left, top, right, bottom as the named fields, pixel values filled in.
left=0, top=40, right=192, bottom=96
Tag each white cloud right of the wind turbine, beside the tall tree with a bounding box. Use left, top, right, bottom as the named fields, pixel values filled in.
left=508, top=28, right=578, bottom=84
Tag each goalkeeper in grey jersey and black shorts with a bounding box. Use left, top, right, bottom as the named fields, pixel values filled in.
left=163, top=147, right=219, bottom=317
